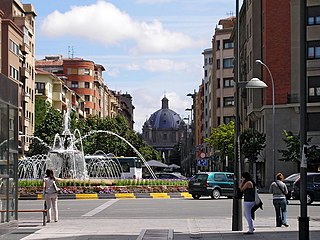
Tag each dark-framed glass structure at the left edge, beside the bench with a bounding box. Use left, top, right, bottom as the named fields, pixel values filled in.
left=0, top=73, right=18, bottom=234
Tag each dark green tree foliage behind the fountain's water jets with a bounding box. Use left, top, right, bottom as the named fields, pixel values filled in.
left=28, top=108, right=160, bottom=160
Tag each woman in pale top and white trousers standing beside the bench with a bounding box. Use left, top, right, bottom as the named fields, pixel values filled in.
left=42, top=169, right=59, bottom=223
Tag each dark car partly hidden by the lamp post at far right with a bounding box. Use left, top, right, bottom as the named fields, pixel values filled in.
left=291, top=172, right=320, bottom=204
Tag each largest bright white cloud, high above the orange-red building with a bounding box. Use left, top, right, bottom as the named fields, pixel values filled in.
left=41, top=1, right=204, bottom=54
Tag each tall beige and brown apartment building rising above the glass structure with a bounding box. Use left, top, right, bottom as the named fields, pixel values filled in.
left=0, top=0, right=36, bottom=155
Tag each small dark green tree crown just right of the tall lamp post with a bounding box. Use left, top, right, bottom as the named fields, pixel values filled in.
left=240, top=128, right=266, bottom=163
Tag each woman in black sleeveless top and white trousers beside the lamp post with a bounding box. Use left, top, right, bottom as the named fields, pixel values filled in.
left=240, top=172, right=255, bottom=234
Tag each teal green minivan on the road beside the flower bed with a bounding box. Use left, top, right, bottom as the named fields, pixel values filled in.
left=188, top=172, right=234, bottom=199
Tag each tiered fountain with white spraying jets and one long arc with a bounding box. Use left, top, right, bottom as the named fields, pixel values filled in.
left=18, top=105, right=156, bottom=179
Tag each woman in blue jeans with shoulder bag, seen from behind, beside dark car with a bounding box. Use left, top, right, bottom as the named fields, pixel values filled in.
left=269, top=173, right=289, bottom=227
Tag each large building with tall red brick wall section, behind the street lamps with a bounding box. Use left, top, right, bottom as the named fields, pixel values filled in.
left=239, top=0, right=320, bottom=186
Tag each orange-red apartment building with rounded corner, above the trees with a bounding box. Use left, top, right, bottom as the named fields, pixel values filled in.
left=36, top=55, right=120, bottom=120
